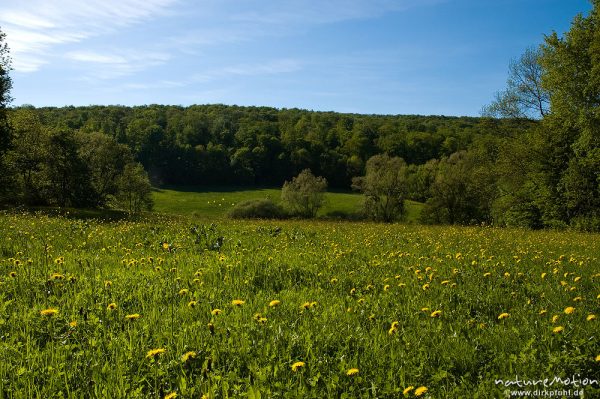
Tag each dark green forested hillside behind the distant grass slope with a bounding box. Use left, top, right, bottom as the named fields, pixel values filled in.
left=8, top=105, right=506, bottom=188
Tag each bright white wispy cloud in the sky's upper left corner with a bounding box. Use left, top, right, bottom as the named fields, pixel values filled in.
left=0, top=0, right=177, bottom=72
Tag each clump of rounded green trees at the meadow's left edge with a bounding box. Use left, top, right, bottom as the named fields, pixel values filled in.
left=4, top=109, right=151, bottom=212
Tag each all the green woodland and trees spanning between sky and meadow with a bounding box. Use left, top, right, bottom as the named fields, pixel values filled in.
left=0, top=1, right=600, bottom=230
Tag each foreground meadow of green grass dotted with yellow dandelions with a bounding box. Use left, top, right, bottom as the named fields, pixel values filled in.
left=0, top=211, right=600, bottom=398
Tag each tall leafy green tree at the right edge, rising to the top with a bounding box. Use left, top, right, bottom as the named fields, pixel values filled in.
left=537, top=0, right=600, bottom=229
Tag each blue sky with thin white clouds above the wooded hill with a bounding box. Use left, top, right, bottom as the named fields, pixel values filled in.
left=0, top=0, right=591, bottom=116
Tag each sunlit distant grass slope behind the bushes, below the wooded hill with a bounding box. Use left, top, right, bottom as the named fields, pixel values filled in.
left=153, top=186, right=422, bottom=221
